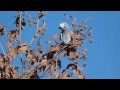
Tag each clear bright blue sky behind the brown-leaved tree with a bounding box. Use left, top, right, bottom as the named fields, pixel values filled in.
left=0, top=11, right=120, bottom=79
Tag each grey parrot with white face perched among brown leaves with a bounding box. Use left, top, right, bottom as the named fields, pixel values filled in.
left=59, top=22, right=72, bottom=45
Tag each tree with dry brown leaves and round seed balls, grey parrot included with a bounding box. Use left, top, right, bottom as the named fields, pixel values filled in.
left=0, top=11, right=93, bottom=79
